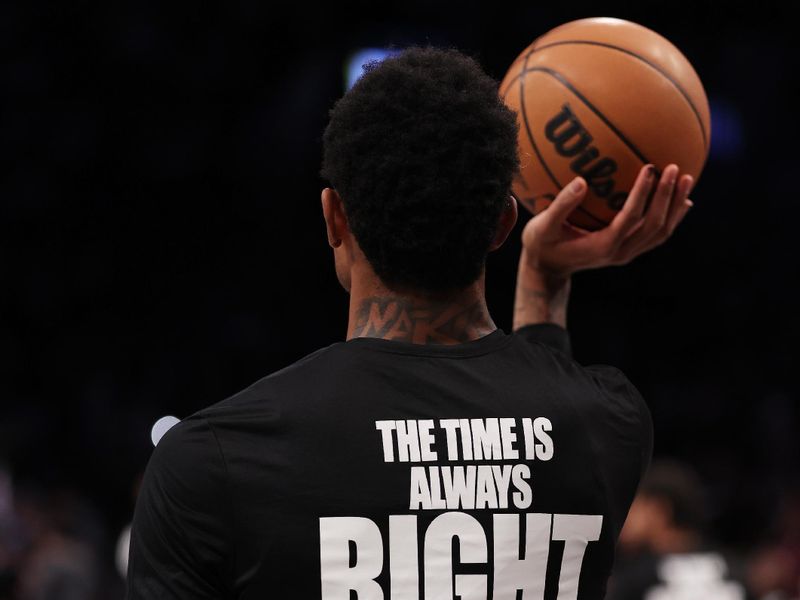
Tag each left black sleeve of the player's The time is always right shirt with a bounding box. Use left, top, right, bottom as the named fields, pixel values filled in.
left=126, top=417, right=233, bottom=600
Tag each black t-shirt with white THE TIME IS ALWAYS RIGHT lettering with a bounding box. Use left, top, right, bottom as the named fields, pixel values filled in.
left=128, top=325, right=652, bottom=600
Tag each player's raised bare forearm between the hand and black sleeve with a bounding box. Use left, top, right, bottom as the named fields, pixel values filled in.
left=514, top=252, right=570, bottom=331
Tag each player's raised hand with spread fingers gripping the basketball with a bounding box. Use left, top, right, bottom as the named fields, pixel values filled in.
left=522, top=165, right=694, bottom=277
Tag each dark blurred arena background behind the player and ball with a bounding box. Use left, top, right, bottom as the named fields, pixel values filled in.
left=0, top=0, right=800, bottom=600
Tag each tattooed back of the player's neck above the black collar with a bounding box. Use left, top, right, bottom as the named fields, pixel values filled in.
left=347, top=276, right=497, bottom=344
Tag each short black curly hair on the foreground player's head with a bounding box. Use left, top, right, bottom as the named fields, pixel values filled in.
left=322, top=48, right=519, bottom=292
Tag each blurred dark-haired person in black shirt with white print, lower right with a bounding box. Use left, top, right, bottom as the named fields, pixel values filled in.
left=608, top=462, right=751, bottom=600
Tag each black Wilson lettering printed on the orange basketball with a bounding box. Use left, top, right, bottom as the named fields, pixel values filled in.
left=544, top=104, right=628, bottom=210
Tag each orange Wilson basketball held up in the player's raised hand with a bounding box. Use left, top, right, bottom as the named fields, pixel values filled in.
left=500, top=18, right=711, bottom=230
